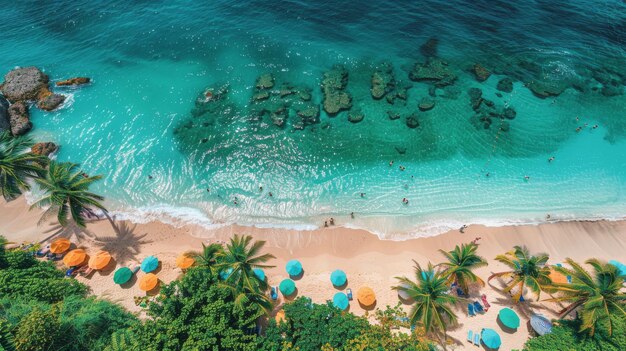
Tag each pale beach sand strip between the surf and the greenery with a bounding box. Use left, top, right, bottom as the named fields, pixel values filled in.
left=0, top=197, right=626, bottom=350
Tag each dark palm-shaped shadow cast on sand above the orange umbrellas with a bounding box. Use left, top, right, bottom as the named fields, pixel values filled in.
left=96, top=220, right=151, bottom=263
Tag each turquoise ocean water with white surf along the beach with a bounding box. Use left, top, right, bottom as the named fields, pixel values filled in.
left=0, top=0, right=626, bottom=238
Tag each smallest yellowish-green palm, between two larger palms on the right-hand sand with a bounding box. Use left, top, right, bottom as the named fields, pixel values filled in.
left=437, top=243, right=487, bottom=295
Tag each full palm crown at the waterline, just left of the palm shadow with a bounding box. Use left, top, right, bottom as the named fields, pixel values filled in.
left=31, top=161, right=107, bottom=228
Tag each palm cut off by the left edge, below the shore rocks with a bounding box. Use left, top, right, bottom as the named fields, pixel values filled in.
left=0, top=132, right=48, bottom=201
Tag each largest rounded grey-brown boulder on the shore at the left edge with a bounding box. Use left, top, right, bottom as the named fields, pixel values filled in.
left=0, top=67, right=48, bottom=102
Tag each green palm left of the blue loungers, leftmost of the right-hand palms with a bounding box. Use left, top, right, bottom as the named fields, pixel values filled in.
left=392, top=261, right=458, bottom=335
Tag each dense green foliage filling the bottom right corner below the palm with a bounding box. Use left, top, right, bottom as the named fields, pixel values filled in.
left=524, top=315, right=626, bottom=351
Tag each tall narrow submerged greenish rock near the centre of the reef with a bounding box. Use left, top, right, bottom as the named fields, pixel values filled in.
left=322, top=66, right=352, bottom=116
